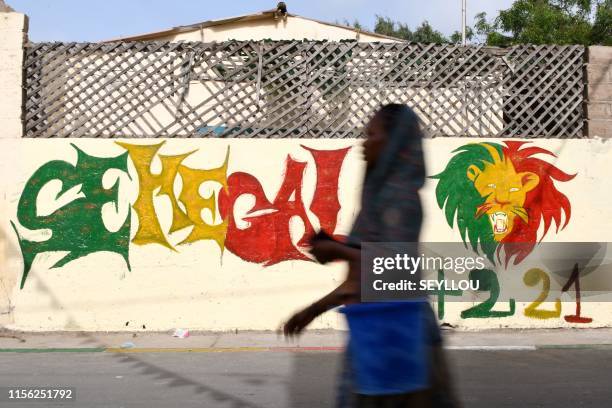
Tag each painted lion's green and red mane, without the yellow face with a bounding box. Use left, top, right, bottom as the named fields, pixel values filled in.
left=430, top=141, right=576, bottom=265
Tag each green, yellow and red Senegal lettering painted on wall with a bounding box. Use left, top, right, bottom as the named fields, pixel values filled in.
left=12, top=142, right=350, bottom=288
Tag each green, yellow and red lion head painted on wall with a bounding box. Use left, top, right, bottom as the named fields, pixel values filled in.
left=431, top=141, right=575, bottom=264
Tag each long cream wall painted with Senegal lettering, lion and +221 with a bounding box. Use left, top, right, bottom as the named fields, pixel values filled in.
left=5, top=138, right=612, bottom=330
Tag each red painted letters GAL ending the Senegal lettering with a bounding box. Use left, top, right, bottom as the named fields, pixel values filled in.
left=219, top=146, right=350, bottom=266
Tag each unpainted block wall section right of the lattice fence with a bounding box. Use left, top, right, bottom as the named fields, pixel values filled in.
left=587, top=46, right=612, bottom=137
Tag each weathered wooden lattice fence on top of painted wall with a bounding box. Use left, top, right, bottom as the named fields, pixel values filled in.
left=25, top=41, right=584, bottom=138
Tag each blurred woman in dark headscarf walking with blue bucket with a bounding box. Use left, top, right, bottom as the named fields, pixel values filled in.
left=284, top=104, right=456, bottom=408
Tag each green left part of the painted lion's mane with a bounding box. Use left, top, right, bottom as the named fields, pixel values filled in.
left=430, top=143, right=503, bottom=263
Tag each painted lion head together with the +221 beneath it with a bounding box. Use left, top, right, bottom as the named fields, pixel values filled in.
left=431, top=141, right=592, bottom=323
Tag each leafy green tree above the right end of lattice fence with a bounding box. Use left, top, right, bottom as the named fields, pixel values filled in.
left=474, top=0, right=612, bottom=46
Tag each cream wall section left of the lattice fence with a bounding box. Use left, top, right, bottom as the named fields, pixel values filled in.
left=0, top=12, right=27, bottom=138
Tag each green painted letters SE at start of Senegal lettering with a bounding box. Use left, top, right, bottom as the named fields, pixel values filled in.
left=11, top=145, right=131, bottom=289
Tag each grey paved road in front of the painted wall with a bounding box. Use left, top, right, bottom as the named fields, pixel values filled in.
left=0, top=348, right=612, bottom=408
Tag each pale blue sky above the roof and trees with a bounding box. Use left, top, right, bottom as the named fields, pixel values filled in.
left=5, top=0, right=512, bottom=41
